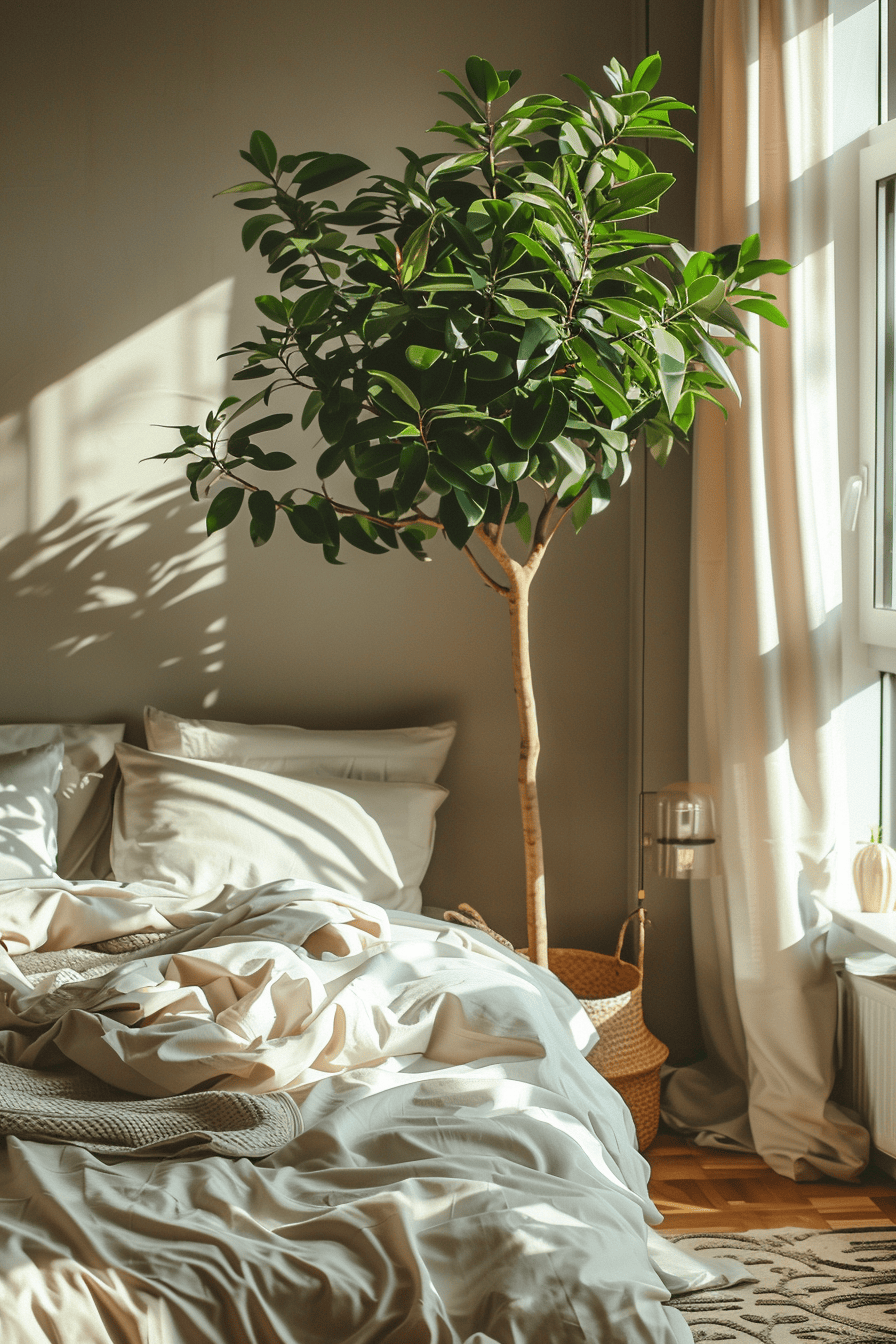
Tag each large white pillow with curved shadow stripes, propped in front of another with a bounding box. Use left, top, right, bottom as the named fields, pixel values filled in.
left=111, top=743, right=443, bottom=910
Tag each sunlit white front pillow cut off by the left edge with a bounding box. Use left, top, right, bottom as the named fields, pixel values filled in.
left=0, top=730, right=64, bottom=880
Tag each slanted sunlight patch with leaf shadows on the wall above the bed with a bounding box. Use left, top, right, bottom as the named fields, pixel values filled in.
left=0, top=280, right=232, bottom=718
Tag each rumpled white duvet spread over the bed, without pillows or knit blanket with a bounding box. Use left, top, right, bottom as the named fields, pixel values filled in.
left=0, top=879, right=690, bottom=1344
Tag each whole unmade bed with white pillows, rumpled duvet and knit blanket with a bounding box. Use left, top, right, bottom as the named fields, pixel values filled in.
left=0, top=710, right=725, bottom=1344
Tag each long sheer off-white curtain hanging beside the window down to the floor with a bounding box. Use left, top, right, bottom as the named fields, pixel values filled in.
left=664, top=0, right=868, bottom=1180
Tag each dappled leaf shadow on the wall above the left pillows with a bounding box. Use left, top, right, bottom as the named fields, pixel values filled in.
left=0, top=481, right=226, bottom=738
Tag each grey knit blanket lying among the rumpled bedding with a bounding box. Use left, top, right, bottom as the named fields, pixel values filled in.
left=0, top=934, right=302, bottom=1159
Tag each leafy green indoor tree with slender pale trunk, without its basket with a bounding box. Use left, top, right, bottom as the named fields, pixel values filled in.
left=157, top=55, right=789, bottom=965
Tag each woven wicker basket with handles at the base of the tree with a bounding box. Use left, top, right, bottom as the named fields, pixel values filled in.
left=445, top=905, right=669, bottom=1152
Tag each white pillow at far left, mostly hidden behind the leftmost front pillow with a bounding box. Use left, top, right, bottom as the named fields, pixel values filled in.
left=0, top=723, right=125, bottom=878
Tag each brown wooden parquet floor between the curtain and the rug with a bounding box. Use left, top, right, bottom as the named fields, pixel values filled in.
left=645, top=1133, right=896, bottom=1232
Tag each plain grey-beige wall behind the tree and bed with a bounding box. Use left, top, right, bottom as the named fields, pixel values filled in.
left=0, top=0, right=700, bottom=1055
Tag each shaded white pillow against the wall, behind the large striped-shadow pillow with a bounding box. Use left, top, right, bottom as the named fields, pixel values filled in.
left=144, top=706, right=457, bottom=784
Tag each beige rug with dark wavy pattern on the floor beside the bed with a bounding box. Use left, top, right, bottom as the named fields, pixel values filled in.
left=669, top=1226, right=896, bottom=1344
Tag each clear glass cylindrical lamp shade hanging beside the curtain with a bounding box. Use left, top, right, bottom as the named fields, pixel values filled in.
left=641, top=782, right=717, bottom=878
